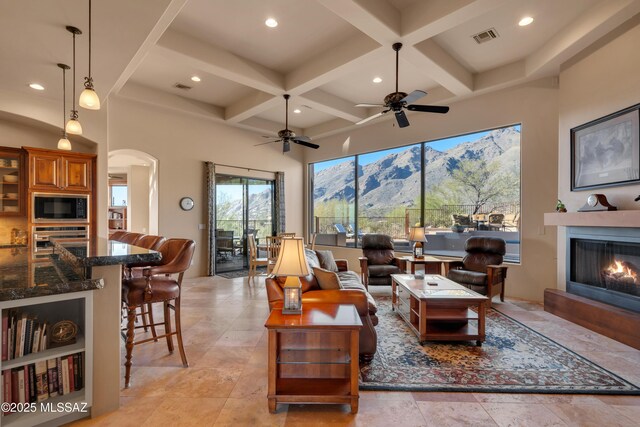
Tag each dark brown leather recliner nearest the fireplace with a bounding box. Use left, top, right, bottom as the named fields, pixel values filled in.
left=447, top=237, right=507, bottom=308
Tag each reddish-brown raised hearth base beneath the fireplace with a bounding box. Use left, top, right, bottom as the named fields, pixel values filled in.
left=544, top=289, right=640, bottom=350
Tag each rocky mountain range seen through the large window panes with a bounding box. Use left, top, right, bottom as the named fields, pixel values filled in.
left=313, top=127, right=520, bottom=213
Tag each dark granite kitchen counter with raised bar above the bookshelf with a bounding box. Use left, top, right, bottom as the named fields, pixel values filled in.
left=0, top=238, right=162, bottom=301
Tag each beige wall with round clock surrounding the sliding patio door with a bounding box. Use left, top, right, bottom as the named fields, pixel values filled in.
left=109, top=97, right=303, bottom=277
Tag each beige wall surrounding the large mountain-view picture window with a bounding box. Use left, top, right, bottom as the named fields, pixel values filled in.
left=305, top=78, right=558, bottom=301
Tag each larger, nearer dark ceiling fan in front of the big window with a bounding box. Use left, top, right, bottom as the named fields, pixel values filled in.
left=356, top=43, right=449, bottom=128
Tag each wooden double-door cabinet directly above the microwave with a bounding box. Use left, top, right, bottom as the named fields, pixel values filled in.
left=26, top=148, right=96, bottom=193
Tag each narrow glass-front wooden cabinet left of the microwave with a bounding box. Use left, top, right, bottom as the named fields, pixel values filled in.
left=0, top=148, right=26, bottom=217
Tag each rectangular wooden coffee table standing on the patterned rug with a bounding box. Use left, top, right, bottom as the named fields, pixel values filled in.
left=391, top=274, right=488, bottom=346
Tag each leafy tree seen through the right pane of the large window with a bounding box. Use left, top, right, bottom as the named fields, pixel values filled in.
left=443, top=160, right=520, bottom=214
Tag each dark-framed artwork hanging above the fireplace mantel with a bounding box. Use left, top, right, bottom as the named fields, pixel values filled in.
left=571, top=104, right=640, bottom=191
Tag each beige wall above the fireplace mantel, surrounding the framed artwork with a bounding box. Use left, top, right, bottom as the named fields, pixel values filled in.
left=557, top=16, right=640, bottom=290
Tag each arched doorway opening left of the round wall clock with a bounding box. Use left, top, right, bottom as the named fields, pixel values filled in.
left=108, top=149, right=159, bottom=234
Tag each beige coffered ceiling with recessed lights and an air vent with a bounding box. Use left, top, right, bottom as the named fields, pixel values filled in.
left=0, top=0, right=640, bottom=137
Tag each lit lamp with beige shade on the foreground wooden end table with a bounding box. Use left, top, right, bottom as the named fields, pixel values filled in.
left=271, top=237, right=309, bottom=314
